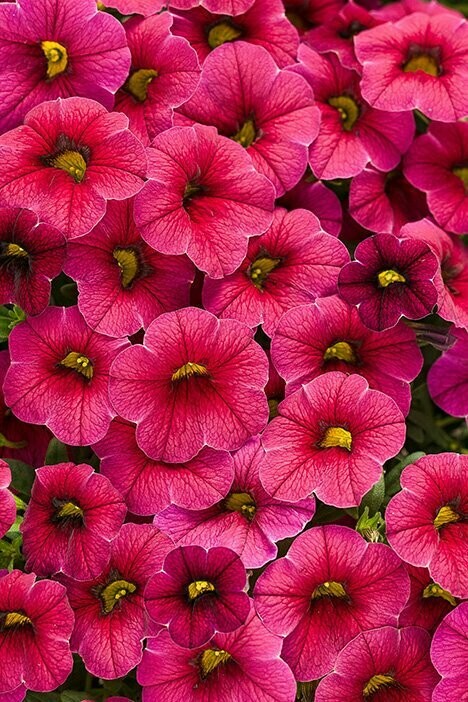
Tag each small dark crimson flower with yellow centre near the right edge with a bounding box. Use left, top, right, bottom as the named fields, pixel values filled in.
left=338, top=234, right=439, bottom=331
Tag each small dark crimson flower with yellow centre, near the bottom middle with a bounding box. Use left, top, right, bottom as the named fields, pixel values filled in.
left=145, top=546, right=250, bottom=648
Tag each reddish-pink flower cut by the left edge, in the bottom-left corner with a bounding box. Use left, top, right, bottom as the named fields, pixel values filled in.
left=0, top=570, right=73, bottom=702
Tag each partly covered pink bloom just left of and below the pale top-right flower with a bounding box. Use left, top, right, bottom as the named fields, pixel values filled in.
left=291, top=44, right=414, bottom=180
